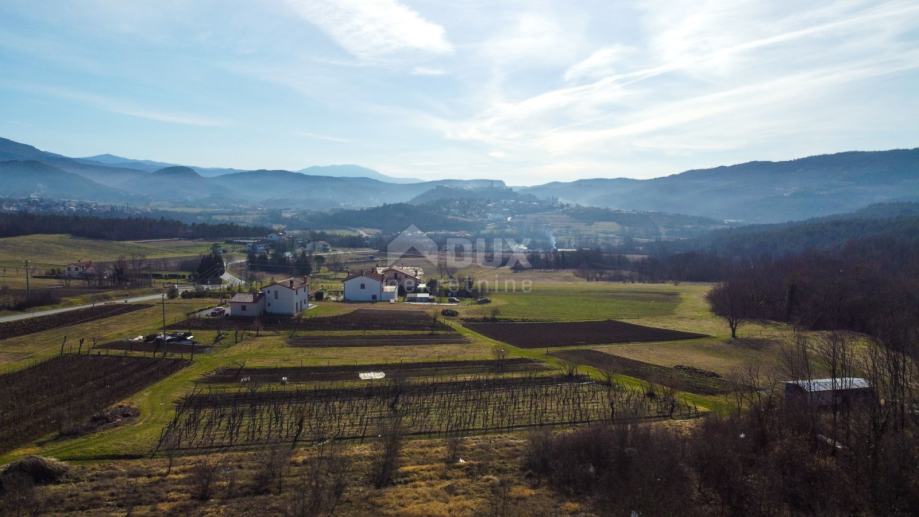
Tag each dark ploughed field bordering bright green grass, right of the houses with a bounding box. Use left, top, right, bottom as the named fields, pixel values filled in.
left=463, top=320, right=704, bottom=348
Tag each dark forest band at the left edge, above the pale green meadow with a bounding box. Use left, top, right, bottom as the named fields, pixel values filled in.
left=0, top=213, right=271, bottom=241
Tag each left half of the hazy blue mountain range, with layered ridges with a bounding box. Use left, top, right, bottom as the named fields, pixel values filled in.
left=0, top=138, right=505, bottom=210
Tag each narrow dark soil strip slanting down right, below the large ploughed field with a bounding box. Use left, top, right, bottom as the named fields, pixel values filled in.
left=551, top=350, right=732, bottom=395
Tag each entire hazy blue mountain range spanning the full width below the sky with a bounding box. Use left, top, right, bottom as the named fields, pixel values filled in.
left=0, top=138, right=919, bottom=223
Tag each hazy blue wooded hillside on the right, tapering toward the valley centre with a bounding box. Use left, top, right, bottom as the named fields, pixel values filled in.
left=521, top=149, right=919, bottom=222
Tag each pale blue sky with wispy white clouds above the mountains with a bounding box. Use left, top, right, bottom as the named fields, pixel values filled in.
left=0, top=0, right=919, bottom=185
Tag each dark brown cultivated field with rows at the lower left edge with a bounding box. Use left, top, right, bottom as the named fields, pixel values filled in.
left=0, top=354, right=188, bottom=451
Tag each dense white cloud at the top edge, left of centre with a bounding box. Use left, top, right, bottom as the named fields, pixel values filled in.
left=287, top=0, right=453, bottom=60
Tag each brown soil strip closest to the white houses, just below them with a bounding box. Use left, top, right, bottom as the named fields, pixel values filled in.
left=171, top=309, right=450, bottom=331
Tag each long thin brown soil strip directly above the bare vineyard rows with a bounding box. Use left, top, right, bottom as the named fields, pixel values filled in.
left=201, top=358, right=548, bottom=383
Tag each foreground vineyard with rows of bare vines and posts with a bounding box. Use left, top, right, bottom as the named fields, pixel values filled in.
left=158, top=375, right=698, bottom=450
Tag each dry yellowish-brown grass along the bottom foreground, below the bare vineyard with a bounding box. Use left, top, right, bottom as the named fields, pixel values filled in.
left=28, top=434, right=590, bottom=516
